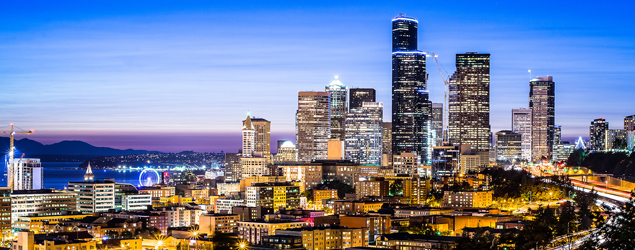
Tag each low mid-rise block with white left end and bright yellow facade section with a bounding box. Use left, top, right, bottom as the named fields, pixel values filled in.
left=245, top=183, right=300, bottom=209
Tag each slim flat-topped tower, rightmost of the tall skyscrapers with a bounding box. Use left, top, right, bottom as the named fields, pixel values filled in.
left=529, top=76, right=556, bottom=161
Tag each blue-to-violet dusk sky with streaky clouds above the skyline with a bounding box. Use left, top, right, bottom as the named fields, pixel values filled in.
left=0, top=3, right=635, bottom=152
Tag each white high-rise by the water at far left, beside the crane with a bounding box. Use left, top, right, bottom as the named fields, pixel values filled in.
left=13, top=158, right=43, bottom=190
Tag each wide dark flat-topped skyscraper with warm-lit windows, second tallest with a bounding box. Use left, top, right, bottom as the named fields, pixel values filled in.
left=448, top=52, right=491, bottom=152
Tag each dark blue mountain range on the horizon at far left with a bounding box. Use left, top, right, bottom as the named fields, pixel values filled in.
left=0, top=137, right=156, bottom=158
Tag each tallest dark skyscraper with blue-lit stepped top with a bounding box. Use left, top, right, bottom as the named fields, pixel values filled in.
left=392, top=15, right=434, bottom=165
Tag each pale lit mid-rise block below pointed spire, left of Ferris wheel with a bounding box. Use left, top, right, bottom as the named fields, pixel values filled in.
left=68, top=179, right=115, bottom=213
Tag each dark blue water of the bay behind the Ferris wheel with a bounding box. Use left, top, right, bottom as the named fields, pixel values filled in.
left=0, top=162, right=140, bottom=190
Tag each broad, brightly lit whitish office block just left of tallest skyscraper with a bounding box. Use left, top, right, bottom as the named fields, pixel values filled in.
left=345, top=102, right=383, bottom=165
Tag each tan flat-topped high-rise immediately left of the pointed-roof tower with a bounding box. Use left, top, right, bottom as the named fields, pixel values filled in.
left=296, top=91, right=331, bottom=162
